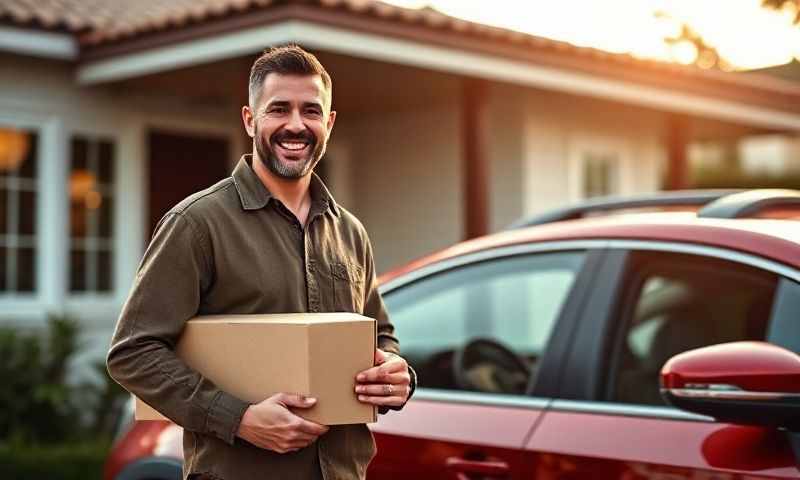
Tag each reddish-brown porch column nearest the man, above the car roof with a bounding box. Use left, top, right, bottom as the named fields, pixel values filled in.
left=461, top=78, right=489, bottom=239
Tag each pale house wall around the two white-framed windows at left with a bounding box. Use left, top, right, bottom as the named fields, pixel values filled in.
left=0, top=54, right=241, bottom=378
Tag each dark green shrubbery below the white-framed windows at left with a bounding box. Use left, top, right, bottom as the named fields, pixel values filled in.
left=0, top=317, right=127, bottom=480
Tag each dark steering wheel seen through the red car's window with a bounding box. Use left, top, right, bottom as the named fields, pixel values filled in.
left=453, top=338, right=531, bottom=394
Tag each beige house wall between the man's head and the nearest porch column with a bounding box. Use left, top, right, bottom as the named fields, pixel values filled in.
left=331, top=105, right=463, bottom=272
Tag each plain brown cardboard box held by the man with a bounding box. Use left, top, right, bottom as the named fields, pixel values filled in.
left=135, top=313, right=377, bottom=425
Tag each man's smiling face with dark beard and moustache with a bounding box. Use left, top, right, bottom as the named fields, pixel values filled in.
left=250, top=73, right=336, bottom=179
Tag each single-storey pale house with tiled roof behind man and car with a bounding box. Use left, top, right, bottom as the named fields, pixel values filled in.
left=0, top=0, right=800, bottom=376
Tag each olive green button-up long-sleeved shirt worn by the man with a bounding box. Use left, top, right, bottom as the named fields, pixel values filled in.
left=107, top=155, right=398, bottom=480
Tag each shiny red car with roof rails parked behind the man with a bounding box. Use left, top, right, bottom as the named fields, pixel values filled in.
left=105, top=191, right=800, bottom=480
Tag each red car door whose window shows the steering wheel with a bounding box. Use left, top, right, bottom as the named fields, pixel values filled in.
left=368, top=246, right=594, bottom=480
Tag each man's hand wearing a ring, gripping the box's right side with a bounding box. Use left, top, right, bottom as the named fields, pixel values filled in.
left=356, top=349, right=411, bottom=407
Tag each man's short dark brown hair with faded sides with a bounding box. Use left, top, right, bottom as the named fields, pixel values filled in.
left=248, top=45, right=333, bottom=108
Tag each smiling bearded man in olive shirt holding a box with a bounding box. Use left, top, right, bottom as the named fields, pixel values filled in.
left=108, top=46, right=415, bottom=480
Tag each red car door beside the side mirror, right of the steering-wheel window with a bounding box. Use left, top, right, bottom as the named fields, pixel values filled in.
left=526, top=242, right=800, bottom=479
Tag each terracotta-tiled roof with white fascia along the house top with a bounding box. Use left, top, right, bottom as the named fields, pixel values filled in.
left=0, top=0, right=800, bottom=131
